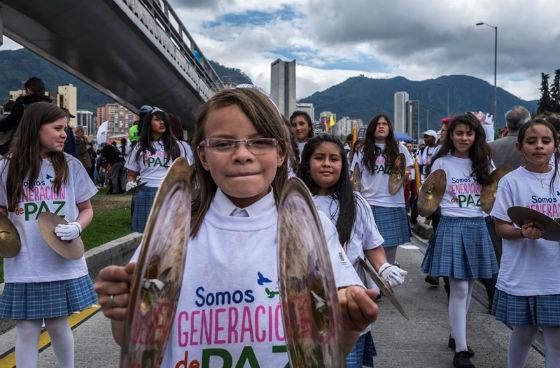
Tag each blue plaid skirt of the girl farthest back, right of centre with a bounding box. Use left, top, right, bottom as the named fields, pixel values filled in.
left=371, top=206, right=410, bottom=248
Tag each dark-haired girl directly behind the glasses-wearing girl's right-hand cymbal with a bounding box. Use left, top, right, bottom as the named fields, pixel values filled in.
left=298, top=134, right=407, bottom=368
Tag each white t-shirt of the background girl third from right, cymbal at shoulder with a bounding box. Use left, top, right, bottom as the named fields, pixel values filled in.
left=350, top=143, right=414, bottom=207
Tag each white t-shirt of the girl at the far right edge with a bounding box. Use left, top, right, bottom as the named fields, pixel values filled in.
left=490, top=167, right=560, bottom=296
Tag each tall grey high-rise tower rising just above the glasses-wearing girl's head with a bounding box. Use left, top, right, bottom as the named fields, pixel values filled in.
left=270, top=59, right=296, bottom=118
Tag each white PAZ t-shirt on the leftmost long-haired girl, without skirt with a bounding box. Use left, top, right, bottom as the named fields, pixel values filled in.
left=0, top=154, right=97, bottom=282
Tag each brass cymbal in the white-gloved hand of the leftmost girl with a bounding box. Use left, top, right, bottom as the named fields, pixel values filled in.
left=37, top=212, right=84, bottom=259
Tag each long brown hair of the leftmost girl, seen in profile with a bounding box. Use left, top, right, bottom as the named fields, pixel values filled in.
left=6, top=102, right=68, bottom=212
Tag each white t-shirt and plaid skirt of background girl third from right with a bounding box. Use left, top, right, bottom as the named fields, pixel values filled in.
left=351, top=144, right=413, bottom=248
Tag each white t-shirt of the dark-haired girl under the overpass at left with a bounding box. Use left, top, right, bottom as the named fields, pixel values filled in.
left=125, top=141, right=192, bottom=188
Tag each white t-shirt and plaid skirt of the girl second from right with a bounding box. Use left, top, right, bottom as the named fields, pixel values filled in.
left=422, top=155, right=498, bottom=280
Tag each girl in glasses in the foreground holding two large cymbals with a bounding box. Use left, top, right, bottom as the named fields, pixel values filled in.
left=96, top=88, right=377, bottom=367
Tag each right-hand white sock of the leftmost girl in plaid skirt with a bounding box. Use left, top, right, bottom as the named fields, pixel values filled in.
left=45, top=317, right=74, bottom=368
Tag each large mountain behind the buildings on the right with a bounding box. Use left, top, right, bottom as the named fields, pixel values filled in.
left=300, top=75, right=537, bottom=130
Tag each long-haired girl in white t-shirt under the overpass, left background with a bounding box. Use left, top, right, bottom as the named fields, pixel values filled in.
left=125, top=107, right=191, bottom=233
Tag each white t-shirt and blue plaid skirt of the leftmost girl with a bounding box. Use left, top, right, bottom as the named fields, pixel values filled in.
left=0, top=154, right=97, bottom=320
